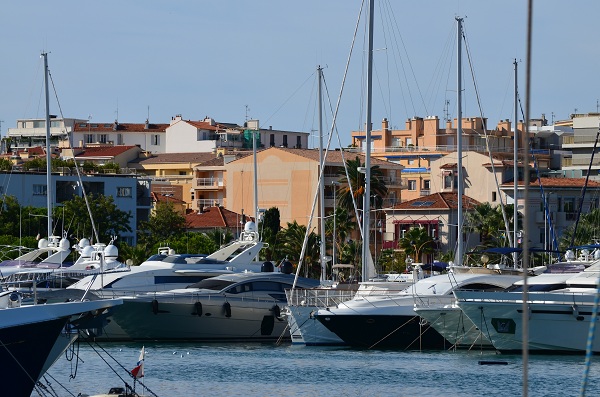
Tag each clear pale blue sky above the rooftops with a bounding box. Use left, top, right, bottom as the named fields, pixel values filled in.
left=0, top=0, right=600, bottom=148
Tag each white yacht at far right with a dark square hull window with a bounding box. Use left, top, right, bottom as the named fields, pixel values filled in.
left=455, top=263, right=600, bottom=353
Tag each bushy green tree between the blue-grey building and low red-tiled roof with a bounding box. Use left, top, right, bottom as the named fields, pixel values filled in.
left=138, top=202, right=186, bottom=245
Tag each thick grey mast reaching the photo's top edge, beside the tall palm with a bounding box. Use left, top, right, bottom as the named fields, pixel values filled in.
left=362, top=0, right=375, bottom=281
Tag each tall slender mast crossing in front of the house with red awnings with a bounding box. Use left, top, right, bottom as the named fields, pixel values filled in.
left=454, top=17, right=463, bottom=266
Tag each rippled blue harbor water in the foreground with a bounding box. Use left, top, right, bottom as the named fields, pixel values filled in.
left=45, top=343, right=600, bottom=397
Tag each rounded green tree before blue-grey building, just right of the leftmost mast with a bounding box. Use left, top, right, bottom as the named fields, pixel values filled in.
left=58, top=194, right=131, bottom=242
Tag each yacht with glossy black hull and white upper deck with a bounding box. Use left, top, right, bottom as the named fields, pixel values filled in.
left=316, top=273, right=520, bottom=350
